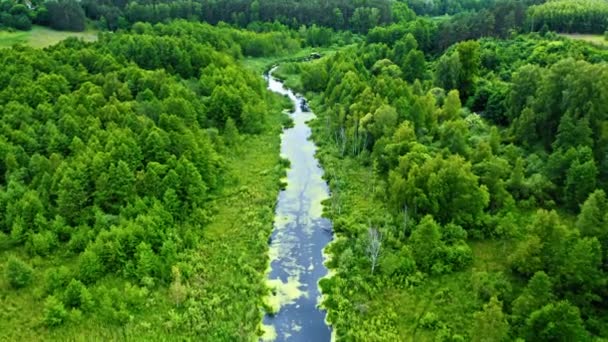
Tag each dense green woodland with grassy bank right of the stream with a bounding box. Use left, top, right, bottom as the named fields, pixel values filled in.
left=276, top=16, right=608, bottom=341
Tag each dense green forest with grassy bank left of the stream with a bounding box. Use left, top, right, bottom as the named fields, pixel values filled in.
left=0, top=22, right=300, bottom=340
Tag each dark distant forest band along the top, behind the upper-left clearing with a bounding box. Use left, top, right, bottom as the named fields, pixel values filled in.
left=0, top=0, right=393, bottom=32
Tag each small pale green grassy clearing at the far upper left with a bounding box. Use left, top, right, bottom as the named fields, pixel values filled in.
left=0, top=26, right=97, bottom=48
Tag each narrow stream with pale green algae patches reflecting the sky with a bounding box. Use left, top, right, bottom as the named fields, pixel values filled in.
left=264, top=69, right=332, bottom=342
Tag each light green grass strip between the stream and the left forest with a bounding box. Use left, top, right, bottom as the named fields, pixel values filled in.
left=184, top=94, right=285, bottom=341
